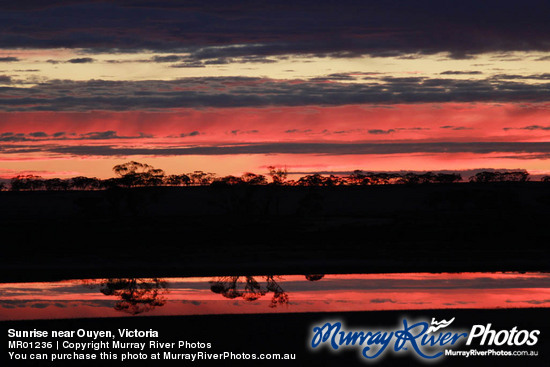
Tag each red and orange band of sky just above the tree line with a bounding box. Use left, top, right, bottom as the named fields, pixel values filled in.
left=0, top=103, right=550, bottom=177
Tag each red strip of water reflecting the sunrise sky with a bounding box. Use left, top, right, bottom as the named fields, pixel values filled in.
left=0, top=273, right=550, bottom=320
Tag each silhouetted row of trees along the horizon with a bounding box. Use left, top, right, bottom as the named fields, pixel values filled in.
left=0, top=161, right=550, bottom=191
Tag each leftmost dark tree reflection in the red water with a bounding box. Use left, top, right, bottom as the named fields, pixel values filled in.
left=85, top=278, right=168, bottom=315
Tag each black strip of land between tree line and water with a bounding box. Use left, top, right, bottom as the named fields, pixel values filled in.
left=0, top=182, right=550, bottom=281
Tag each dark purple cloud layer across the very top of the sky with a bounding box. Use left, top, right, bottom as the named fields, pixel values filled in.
left=0, top=0, right=550, bottom=60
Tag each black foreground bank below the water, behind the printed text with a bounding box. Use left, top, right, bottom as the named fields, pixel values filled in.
left=0, top=308, right=550, bottom=366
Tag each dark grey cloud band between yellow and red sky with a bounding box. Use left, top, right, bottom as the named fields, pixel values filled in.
left=0, top=77, right=550, bottom=111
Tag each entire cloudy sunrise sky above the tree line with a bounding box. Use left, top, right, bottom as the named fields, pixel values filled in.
left=0, top=0, right=550, bottom=178
